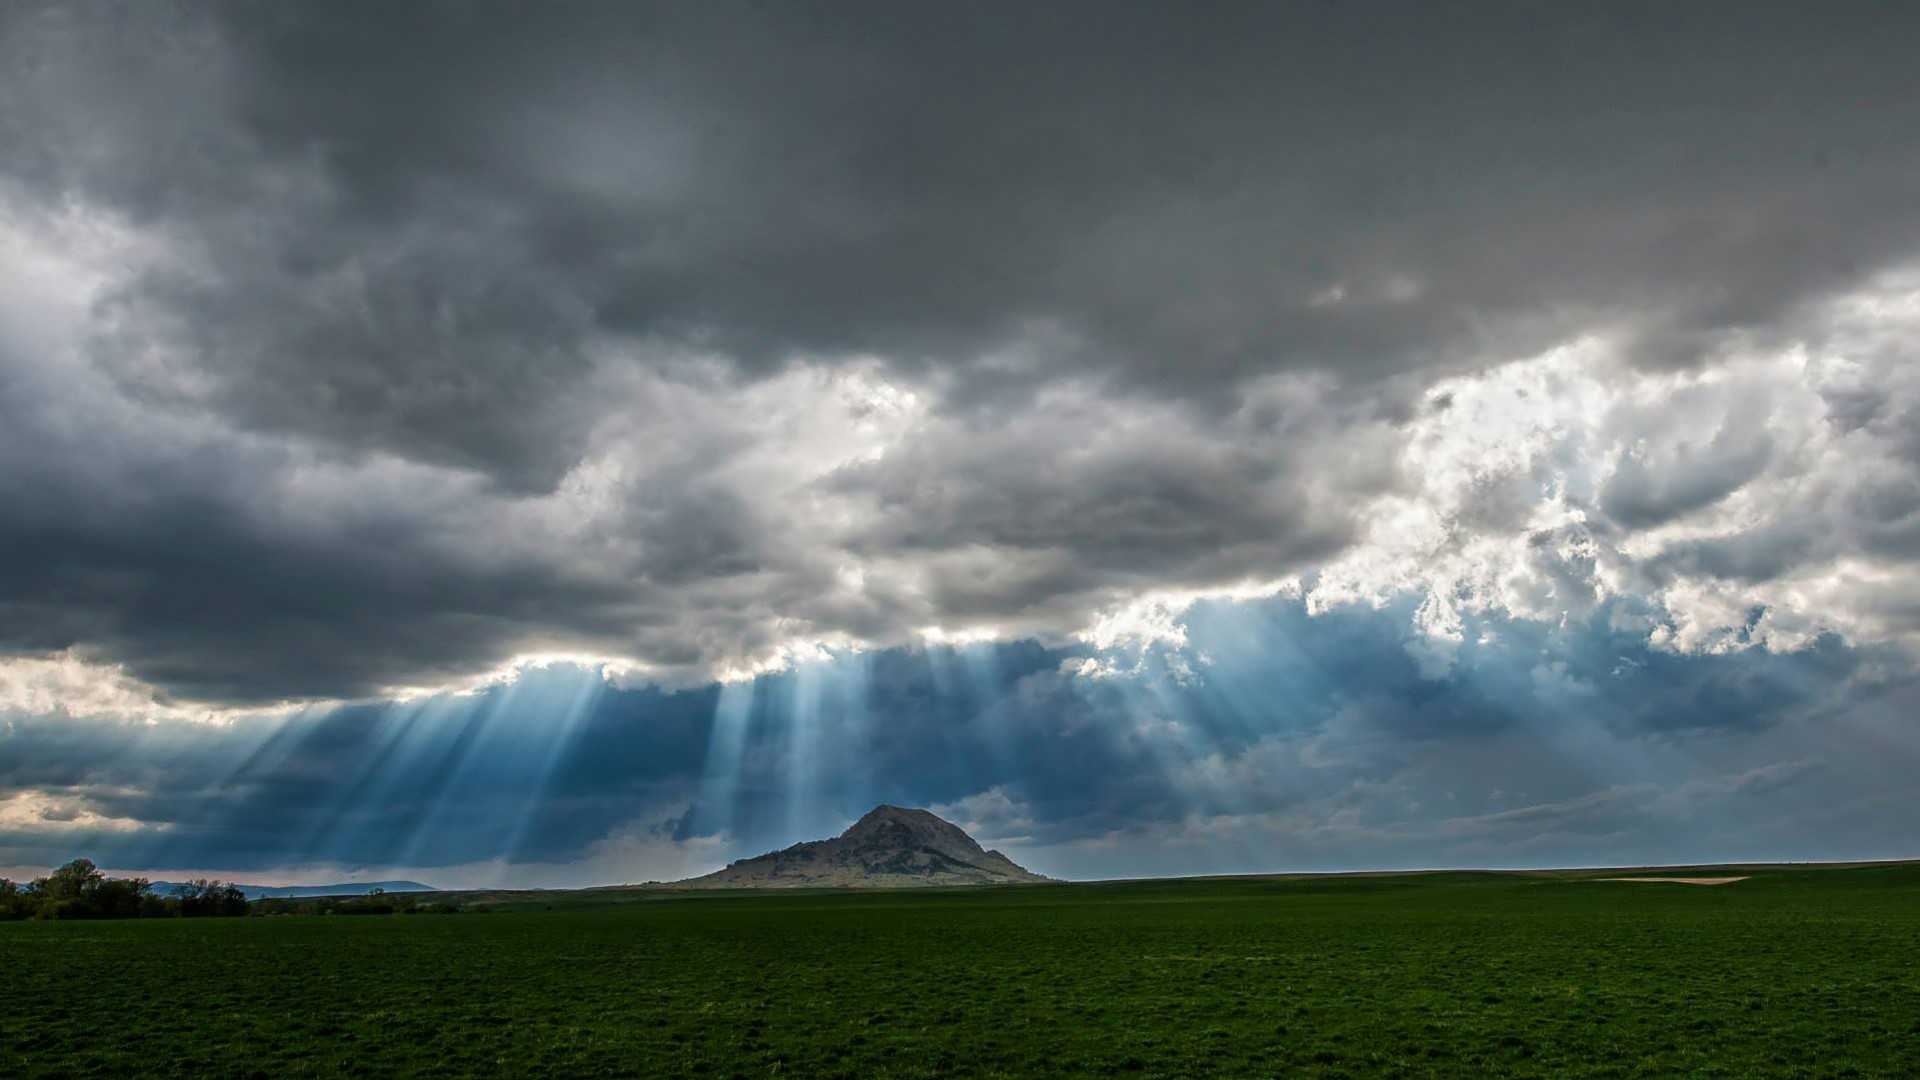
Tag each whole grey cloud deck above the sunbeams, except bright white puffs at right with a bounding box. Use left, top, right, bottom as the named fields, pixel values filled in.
left=11, top=4, right=1920, bottom=701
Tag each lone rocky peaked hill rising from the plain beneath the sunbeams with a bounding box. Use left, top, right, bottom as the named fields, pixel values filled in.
left=670, top=805, right=1052, bottom=888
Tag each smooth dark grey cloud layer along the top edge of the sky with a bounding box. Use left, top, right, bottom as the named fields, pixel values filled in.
left=227, top=4, right=1920, bottom=386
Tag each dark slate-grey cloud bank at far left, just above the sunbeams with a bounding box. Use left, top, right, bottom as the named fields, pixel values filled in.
left=0, top=484, right=605, bottom=701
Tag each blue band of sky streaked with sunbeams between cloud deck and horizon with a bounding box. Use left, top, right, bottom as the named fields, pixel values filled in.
left=0, top=600, right=1914, bottom=876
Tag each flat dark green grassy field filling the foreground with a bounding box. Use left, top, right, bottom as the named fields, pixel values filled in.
left=0, top=865, right=1920, bottom=1078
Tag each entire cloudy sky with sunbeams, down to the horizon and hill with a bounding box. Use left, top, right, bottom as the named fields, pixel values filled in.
left=0, top=0, right=1920, bottom=886
